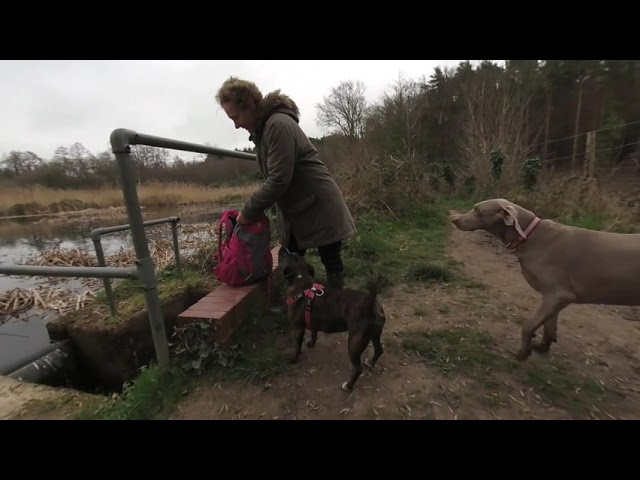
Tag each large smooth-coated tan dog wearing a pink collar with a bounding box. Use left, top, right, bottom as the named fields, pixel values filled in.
left=453, top=198, right=640, bottom=360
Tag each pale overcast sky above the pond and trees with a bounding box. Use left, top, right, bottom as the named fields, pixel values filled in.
left=0, top=60, right=488, bottom=159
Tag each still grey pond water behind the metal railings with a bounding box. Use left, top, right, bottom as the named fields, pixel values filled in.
left=0, top=207, right=228, bottom=375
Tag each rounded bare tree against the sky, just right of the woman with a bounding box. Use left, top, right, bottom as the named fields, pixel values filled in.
left=316, top=80, right=367, bottom=139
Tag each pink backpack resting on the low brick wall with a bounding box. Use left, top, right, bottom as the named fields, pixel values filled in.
left=213, top=210, right=273, bottom=287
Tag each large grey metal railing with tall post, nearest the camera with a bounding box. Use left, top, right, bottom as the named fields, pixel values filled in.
left=0, top=128, right=256, bottom=369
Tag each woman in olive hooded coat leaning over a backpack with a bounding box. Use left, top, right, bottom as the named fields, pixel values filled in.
left=216, top=77, right=356, bottom=288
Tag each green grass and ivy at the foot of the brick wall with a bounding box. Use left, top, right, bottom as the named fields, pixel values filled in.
left=75, top=272, right=289, bottom=420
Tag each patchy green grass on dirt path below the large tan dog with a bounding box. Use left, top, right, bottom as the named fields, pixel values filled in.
left=401, top=327, right=606, bottom=414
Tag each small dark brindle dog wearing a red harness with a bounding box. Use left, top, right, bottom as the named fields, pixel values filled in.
left=281, top=253, right=386, bottom=392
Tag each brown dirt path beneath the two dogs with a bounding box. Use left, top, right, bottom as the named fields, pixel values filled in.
left=173, top=219, right=640, bottom=419
